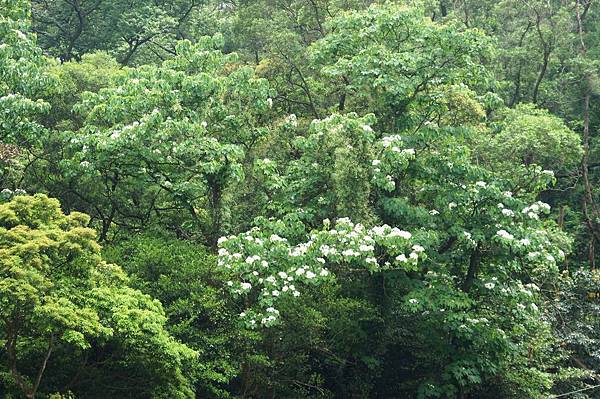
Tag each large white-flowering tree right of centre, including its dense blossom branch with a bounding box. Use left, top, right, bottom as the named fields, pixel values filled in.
left=219, top=104, right=570, bottom=396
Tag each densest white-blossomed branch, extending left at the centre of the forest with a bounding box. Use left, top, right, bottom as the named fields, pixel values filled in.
left=218, top=218, right=426, bottom=325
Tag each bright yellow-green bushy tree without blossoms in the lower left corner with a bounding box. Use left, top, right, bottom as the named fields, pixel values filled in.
left=0, top=195, right=195, bottom=398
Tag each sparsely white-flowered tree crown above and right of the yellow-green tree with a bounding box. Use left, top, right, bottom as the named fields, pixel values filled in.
left=56, top=36, right=271, bottom=244
